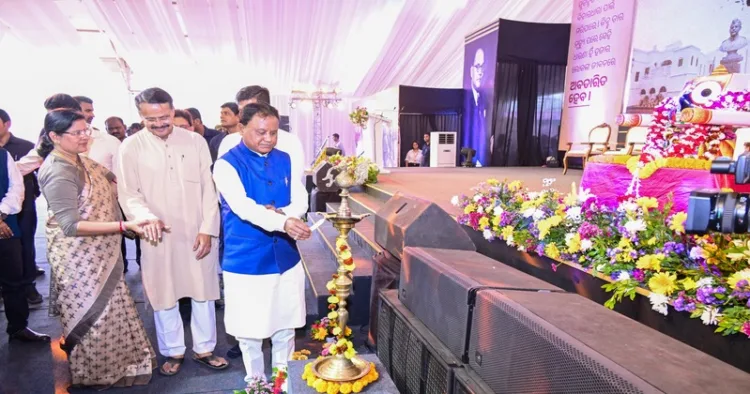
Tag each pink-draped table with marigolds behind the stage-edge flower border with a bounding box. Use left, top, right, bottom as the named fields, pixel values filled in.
left=581, top=162, right=750, bottom=211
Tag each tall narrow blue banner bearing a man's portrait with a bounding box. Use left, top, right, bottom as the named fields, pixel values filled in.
left=461, top=30, right=497, bottom=166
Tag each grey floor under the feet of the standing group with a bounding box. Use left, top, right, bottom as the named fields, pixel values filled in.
left=0, top=200, right=367, bottom=394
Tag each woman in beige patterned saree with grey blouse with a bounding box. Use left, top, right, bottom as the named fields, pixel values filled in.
left=39, top=110, right=156, bottom=387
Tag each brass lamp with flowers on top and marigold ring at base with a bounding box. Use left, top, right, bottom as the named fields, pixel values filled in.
left=302, top=156, right=378, bottom=393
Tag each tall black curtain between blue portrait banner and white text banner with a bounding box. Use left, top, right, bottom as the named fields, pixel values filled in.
left=491, top=19, right=570, bottom=167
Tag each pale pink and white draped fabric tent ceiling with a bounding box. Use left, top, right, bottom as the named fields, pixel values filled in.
left=0, top=0, right=573, bottom=97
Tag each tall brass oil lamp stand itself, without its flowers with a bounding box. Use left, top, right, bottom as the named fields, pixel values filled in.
left=311, top=171, right=371, bottom=382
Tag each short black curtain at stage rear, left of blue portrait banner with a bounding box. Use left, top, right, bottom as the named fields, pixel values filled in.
left=398, top=113, right=461, bottom=167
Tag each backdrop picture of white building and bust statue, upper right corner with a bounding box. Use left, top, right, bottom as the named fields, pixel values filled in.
left=623, top=0, right=750, bottom=114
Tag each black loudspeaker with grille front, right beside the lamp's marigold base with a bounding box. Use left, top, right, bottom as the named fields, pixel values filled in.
left=377, top=290, right=461, bottom=394
